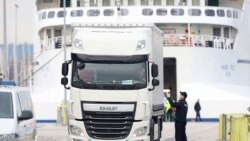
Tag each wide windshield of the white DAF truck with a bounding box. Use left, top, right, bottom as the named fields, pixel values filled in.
left=72, top=61, right=147, bottom=89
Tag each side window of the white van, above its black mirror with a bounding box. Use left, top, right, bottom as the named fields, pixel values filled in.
left=18, top=92, right=33, bottom=111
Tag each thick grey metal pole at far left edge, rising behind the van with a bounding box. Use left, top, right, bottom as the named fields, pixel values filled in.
left=2, top=0, right=9, bottom=80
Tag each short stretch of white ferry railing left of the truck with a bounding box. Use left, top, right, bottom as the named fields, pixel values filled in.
left=41, top=36, right=71, bottom=50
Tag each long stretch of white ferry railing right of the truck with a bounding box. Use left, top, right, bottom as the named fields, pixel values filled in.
left=163, top=34, right=234, bottom=49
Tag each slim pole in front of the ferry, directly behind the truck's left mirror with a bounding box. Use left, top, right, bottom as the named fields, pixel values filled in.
left=63, top=0, right=67, bottom=105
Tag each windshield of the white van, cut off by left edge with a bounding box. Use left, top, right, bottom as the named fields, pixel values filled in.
left=0, top=92, right=13, bottom=118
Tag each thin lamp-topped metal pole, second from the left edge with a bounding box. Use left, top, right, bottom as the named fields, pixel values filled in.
left=13, top=4, right=19, bottom=84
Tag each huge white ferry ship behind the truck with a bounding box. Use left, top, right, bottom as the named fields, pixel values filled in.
left=33, top=0, right=250, bottom=121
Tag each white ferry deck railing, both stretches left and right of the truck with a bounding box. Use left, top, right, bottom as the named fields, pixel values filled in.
left=41, top=34, right=234, bottom=51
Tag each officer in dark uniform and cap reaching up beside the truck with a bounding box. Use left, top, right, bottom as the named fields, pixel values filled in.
left=167, top=92, right=188, bottom=141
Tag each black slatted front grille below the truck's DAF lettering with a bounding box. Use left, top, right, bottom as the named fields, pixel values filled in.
left=84, top=112, right=134, bottom=140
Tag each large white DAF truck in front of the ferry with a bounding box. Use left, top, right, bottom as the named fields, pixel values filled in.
left=61, top=24, right=164, bottom=141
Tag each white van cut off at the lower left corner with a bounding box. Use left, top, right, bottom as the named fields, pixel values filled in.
left=0, top=86, right=36, bottom=141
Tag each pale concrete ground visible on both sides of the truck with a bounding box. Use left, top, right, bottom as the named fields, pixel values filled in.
left=37, top=122, right=218, bottom=141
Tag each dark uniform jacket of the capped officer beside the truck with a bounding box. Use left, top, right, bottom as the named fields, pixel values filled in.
left=168, top=98, right=188, bottom=122
